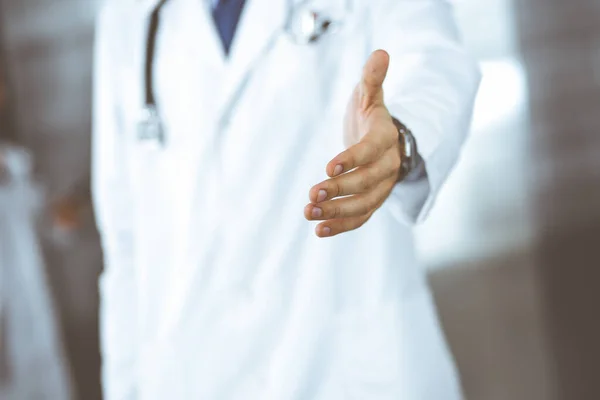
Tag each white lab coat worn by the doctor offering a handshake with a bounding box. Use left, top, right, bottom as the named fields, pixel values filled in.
left=93, top=0, right=479, bottom=400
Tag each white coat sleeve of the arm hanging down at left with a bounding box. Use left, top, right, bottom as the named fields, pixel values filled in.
left=92, top=3, right=137, bottom=400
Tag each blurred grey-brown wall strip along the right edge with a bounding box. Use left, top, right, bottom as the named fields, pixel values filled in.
left=515, top=0, right=600, bottom=400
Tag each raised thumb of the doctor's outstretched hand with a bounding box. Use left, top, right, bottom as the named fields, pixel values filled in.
left=360, top=50, right=390, bottom=110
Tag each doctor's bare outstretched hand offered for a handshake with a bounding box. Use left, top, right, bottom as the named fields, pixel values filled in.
left=304, top=50, right=401, bottom=237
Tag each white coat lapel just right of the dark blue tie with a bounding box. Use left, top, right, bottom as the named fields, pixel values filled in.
left=221, top=0, right=291, bottom=120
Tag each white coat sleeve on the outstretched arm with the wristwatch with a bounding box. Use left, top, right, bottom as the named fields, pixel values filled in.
left=367, top=0, right=481, bottom=224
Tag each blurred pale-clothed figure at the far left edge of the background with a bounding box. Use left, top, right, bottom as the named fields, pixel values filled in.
left=0, top=75, right=72, bottom=400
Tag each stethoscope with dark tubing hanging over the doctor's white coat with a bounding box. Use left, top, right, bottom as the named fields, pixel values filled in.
left=137, top=0, right=353, bottom=148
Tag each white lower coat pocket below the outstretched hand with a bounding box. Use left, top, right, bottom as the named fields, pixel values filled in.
left=335, top=302, right=402, bottom=400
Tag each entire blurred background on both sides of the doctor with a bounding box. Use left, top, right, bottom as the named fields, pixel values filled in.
left=0, top=0, right=600, bottom=400
